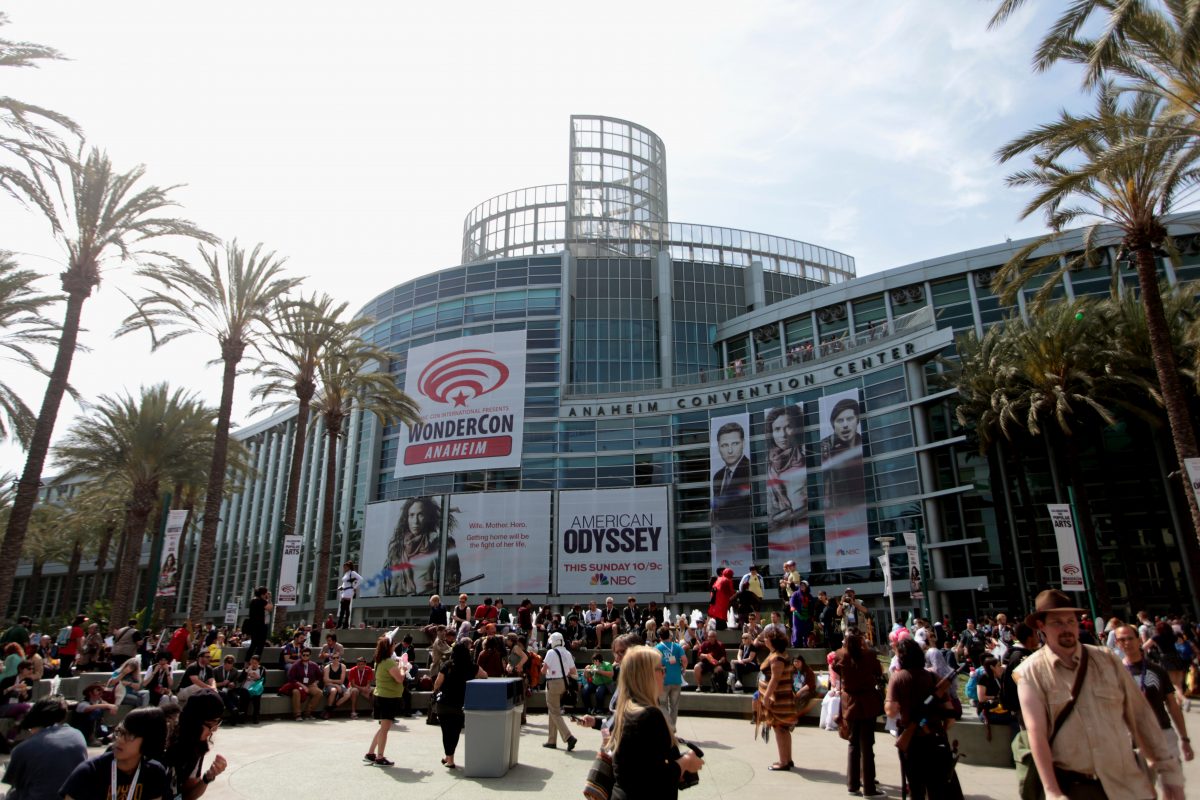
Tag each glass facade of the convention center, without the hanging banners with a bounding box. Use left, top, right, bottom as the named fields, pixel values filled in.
left=18, top=118, right=1200, bottom=624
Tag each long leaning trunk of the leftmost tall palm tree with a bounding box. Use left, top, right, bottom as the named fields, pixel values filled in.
left=0, top=287, right=91, bottom=612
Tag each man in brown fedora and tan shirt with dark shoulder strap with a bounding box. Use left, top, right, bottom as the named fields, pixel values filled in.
left=1014, top=589, right=1183, bottom=800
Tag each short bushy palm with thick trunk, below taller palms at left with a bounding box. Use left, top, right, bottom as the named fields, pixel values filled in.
left=54, top=384, right=216, bottom=620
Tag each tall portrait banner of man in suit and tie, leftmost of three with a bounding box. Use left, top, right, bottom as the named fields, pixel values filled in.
left=708, top=414, right=754, bottom=576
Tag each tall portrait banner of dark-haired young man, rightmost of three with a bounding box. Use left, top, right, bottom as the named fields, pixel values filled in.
left=818, top=389, right=871, bottom=570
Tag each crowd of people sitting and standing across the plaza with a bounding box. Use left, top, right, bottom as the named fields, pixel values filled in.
left=0, top=575, right=1200, bottom=798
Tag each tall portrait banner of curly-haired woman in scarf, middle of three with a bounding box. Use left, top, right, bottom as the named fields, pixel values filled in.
left=763, top=403, right=812, bottom=575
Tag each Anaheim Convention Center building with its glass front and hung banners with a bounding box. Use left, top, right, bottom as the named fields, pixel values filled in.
left=28, top=116, right=1200, bottom=624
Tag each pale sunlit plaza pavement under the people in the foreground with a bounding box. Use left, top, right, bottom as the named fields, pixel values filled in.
left=175, top=705, right=1200, bottom=800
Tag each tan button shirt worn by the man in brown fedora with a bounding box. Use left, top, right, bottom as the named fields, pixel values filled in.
left=1014, top=644, right=1183, bottom=800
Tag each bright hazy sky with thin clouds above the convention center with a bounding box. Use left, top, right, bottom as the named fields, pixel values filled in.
left=0, top=0, right=1088, bottom=474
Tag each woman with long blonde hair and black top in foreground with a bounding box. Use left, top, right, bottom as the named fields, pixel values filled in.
left=608, top=645, right=704, bottom=800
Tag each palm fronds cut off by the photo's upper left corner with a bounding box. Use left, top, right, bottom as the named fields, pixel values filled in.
left=0, top=12, right=80, bottom=223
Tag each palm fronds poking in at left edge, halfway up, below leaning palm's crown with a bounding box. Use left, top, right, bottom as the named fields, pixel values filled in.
left=0, top=251, right=58, bottom=446
